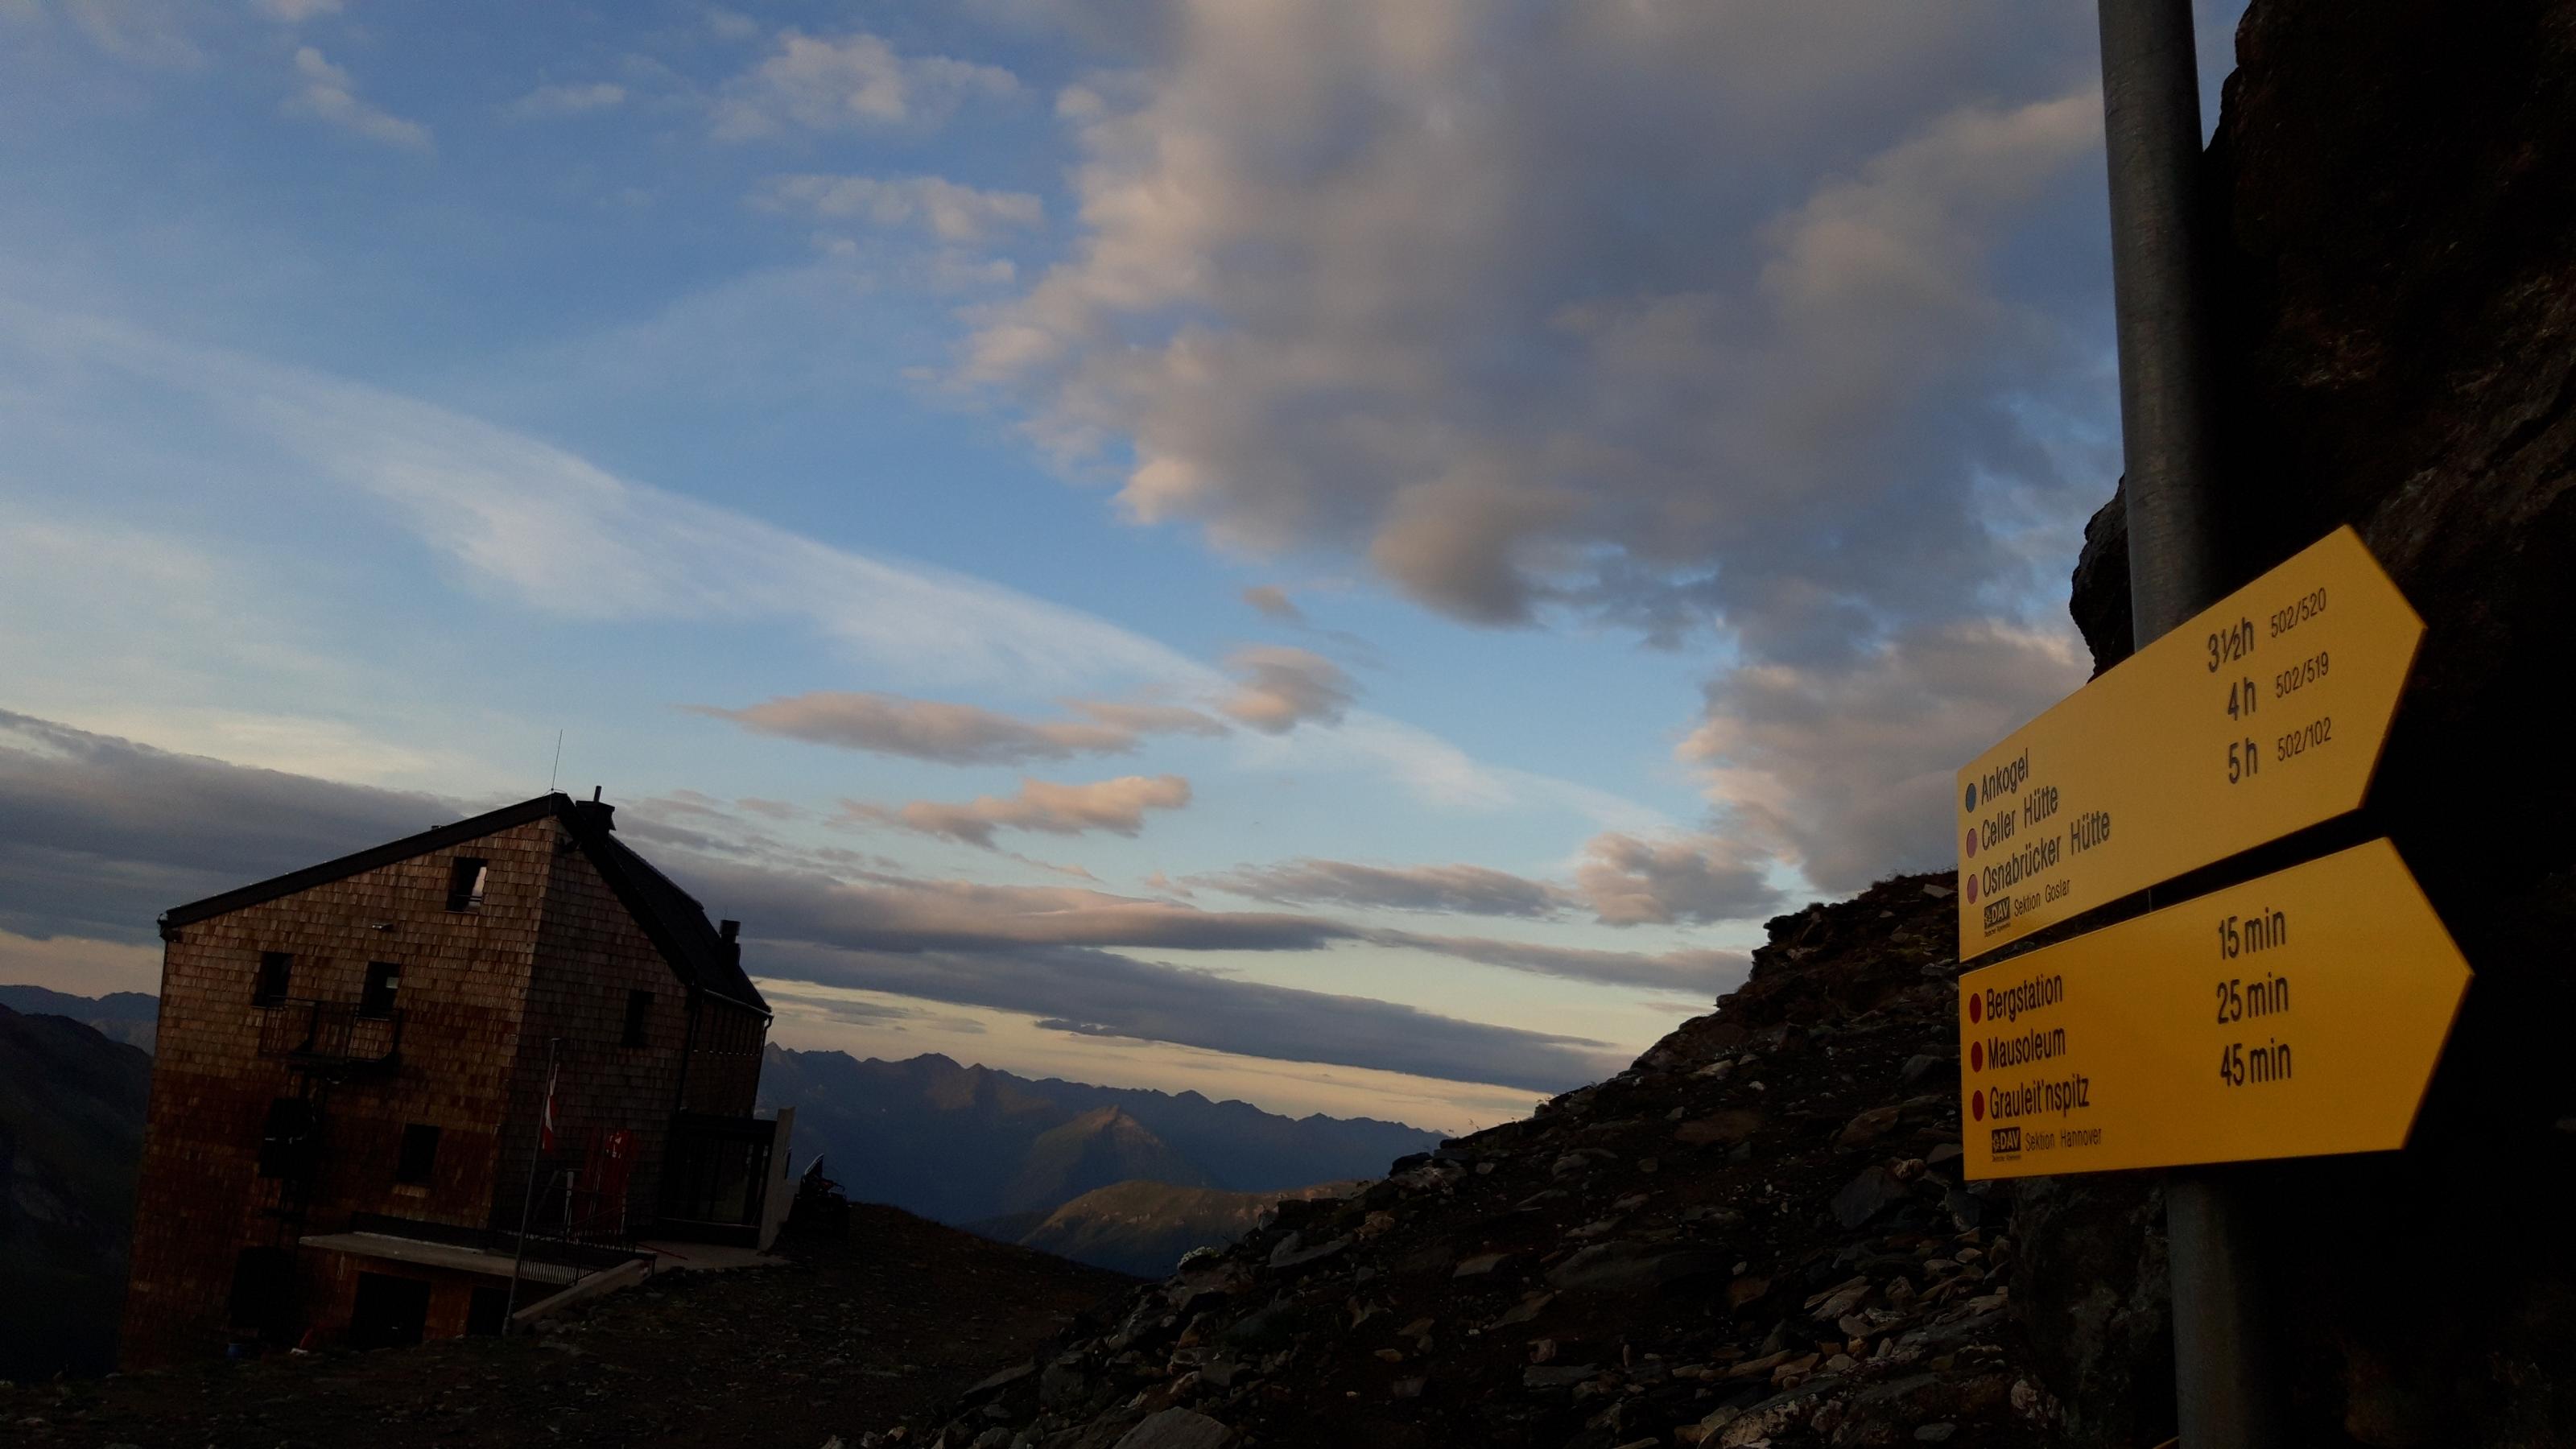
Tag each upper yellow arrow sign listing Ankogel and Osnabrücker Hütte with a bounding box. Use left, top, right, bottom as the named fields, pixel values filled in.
left=1955, top=529, right=2424, bottom=962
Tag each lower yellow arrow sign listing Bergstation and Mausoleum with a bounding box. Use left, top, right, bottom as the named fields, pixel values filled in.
left=1958, top=840, right=2468, bottom=1179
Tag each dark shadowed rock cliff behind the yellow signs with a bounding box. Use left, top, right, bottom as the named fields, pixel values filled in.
left=2061, top=0, right=2576, bottom=1447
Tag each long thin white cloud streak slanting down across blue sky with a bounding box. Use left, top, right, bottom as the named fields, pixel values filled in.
left=0, top=299, right=1670, bottom=830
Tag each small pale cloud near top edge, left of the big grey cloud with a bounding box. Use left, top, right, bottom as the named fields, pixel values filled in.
left=716, top=31, right=1020, bottom=142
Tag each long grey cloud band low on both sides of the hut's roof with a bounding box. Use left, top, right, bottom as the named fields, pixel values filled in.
left=0, top=714, right=1718, bottom=1091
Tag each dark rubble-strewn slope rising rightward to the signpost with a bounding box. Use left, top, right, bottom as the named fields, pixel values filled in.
left=886, top=877, right=2070, bottom=1449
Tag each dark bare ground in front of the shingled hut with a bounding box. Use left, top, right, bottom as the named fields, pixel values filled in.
left=0, top=1207, right=1131, bottom=1449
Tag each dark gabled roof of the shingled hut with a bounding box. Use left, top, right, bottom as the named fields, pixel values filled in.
left=159, top=791, right=770, bottom=1016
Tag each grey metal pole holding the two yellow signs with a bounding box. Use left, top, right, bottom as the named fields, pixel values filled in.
left=2099, top=0, right=2280, bottom=1449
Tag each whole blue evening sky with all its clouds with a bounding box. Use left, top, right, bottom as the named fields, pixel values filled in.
left=0, top=0, right=2236, bottom=1129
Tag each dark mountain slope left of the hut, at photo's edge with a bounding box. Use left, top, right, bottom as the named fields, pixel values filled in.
left=0, top=1005, right=152, bottom=1380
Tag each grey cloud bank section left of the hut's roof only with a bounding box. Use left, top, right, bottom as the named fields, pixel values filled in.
left=0, top=712, right=464, bottom=941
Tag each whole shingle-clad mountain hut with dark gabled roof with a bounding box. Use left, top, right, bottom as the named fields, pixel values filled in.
left=121, top=794, right=786, bottom=1367
